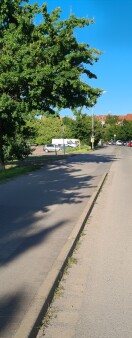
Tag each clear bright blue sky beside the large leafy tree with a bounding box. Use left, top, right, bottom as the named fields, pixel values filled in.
left=30, top=0, right=132, bottom=116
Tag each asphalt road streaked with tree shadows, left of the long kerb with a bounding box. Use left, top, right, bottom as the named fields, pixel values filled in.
left=0, top=147, right=116, bottom=338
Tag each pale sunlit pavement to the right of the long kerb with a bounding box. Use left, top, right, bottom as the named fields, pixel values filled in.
left=37, top=147, right=132, bottom=338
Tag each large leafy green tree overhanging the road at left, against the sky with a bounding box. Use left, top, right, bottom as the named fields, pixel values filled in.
left=0, top=0, right=101, bottom=168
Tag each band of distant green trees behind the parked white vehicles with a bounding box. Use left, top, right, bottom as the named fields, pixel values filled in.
left=28, top=114, right=132, bottom=145
